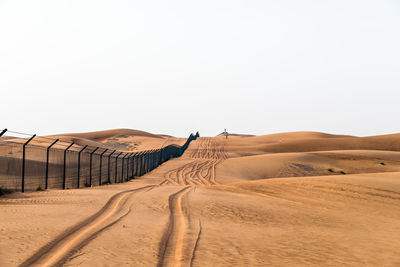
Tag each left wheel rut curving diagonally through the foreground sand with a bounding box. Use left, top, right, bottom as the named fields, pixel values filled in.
left=20, top=185, right=155, bottom=267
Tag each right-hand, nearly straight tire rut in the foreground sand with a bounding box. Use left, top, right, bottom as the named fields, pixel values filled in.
left=157, top=186, right=201, bottom=267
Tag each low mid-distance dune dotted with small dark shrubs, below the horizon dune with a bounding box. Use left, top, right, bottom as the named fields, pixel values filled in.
left=217, top=150, right=400, bottom=182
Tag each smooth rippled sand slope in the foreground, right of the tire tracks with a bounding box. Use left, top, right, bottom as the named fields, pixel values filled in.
left=193, top=173, right=400, bottom=266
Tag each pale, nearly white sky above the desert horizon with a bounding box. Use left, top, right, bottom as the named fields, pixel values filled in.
left=0, top=0, right=400, bottom=136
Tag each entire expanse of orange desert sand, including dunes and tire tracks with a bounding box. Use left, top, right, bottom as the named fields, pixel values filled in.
left=0, top=130, right=400, bottom=266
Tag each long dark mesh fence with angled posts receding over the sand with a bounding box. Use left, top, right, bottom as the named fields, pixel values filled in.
left=0, top=129, right=200, bottom=192
